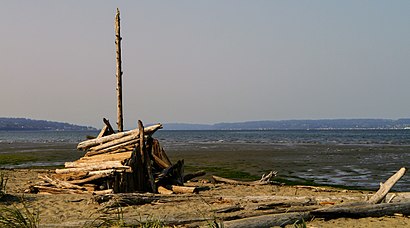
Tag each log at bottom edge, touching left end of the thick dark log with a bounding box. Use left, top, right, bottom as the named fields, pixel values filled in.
left=224, top=212, right=312, bottom=228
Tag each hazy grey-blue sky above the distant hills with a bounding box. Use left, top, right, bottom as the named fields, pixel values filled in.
left=0, top=0, right=410, bottom=128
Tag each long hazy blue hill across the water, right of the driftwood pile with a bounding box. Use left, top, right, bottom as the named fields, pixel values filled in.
left=164, top=119, right=410, bottom=130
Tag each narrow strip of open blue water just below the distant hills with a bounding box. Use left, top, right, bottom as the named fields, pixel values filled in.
left=0, top=130, right=410, bottom=145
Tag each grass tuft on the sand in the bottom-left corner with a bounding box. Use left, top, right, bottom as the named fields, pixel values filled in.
left=0, top=200, right=40, bottom=228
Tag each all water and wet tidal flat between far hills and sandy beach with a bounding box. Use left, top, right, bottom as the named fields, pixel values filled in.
left=0, top=130, right=410, bottom=191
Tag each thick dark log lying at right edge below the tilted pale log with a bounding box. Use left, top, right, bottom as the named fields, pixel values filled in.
left=311, top=202, right=410, bottom=219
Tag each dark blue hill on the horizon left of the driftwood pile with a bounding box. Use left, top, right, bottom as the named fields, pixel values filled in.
left=0, top=117, right=96, bottom=131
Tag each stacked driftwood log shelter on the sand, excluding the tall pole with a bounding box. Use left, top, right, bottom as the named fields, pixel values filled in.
left=31, top=119, right=204, bottom=194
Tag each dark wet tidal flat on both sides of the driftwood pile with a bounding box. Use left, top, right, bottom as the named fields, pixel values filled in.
left=0, top=142, right=410, bottom=191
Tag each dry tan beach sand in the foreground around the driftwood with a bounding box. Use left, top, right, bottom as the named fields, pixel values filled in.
left=0, top=169, right=410, bottom=227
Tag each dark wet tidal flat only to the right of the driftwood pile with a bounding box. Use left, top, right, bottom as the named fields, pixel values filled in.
left=167, top=143, right=410, bottom=191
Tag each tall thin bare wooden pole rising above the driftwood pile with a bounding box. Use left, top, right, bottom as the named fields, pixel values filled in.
left=115, top=8, right=124, bottom=132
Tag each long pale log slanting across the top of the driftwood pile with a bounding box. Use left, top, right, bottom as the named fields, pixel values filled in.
left=77, top=124, right=162, bottom=150
